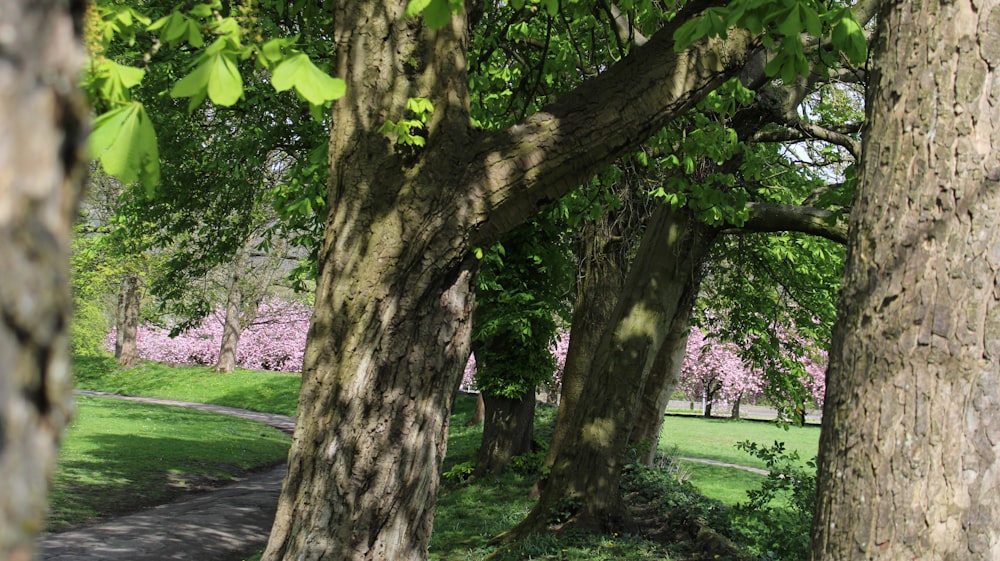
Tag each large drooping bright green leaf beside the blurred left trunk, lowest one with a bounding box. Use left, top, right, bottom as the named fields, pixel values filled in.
left=88, top=102, right=160, bottom=192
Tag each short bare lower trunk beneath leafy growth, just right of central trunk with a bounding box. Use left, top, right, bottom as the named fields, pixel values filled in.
left=475, top=392, right=535, bottom=476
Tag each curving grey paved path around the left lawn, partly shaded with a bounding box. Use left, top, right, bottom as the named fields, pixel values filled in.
left=38, top=391, right=295, bottom=561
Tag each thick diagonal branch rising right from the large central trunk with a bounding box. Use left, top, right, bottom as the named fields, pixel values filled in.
left=464, top=6, right=759, bottom=245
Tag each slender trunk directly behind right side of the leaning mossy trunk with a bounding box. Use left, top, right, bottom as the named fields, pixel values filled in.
left=629, top=298, right=701, bottom=465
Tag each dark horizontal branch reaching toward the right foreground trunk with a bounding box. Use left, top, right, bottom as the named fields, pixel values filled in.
left=722, top=203, right=847, bottom=244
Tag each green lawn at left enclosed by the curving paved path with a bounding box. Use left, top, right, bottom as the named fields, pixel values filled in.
left=48, top=396, right=290, bottom=531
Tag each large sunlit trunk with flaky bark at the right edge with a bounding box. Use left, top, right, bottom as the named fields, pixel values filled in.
left=812, top=0, right=1000, bottom=561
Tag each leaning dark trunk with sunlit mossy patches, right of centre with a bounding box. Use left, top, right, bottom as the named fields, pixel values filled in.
left=508, top=206, right=712, bottom=538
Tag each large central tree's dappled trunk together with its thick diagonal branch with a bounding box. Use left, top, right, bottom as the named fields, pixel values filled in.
left=264, top=1, right=756, bottom=561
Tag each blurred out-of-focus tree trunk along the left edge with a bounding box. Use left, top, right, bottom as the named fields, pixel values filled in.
left=0, top=0, right=86, bottom=561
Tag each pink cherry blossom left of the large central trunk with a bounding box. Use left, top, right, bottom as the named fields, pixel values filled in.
left=105, top=300, right=312, bottom=372
